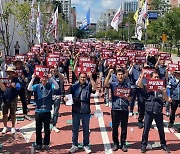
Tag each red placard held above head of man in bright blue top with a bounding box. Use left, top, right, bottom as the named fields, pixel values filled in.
left=35, top=66, right=50, bottom=78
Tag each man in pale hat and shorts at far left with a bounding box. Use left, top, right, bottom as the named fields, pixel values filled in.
left=2, top=66, right=19, bottom=134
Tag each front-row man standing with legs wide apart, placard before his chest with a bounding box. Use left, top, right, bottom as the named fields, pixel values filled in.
left=137, top=72, right=170, bottom=153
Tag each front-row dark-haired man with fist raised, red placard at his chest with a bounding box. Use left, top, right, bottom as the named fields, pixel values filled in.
left=104, top=68, right=131, bottom=152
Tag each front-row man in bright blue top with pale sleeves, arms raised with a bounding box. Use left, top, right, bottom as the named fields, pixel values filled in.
left=28, top=74, right=59, bottom=151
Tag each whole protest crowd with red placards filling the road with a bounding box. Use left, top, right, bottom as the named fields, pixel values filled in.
left=0, top=41, right=180, bottom=153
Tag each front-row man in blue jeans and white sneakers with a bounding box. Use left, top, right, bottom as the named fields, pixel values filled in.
left=64, top=72, right=97, bottom=153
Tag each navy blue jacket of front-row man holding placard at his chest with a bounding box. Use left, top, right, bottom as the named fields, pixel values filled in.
left=110, top=79, right=131, bottom=111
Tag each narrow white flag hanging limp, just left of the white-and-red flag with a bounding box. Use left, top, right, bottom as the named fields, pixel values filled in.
left=36, top=3, right=42, bottom=44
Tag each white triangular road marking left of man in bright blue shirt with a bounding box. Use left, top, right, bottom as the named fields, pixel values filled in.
left=19, top=121, right=36, bottom=143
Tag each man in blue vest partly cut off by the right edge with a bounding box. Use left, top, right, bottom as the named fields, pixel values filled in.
left=167, top=71, right=180, bottom=128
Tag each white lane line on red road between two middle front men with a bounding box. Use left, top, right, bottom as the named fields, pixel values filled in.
left=93, top=93, right=112, bottom=154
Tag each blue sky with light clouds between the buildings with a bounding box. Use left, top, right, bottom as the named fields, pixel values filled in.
left=71, top=0, right=137, bottom=23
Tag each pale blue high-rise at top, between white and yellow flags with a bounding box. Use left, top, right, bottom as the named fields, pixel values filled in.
left=123, top=0, right=138, bottom=13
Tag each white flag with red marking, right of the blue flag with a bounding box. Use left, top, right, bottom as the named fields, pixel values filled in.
left=111, top=5, right=124, bottom=31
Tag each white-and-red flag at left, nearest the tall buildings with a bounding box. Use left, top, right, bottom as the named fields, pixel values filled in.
left=47, top=7, right=58, bottom=40
